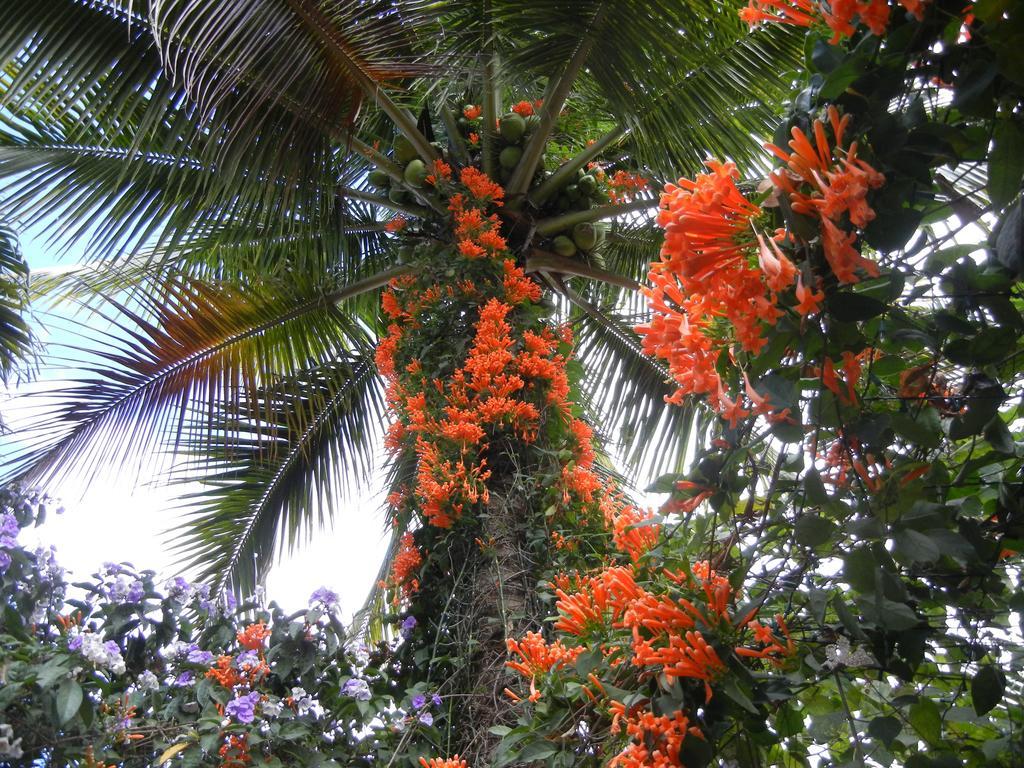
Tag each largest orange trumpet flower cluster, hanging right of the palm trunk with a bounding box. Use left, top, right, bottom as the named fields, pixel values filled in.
left=636, top=161, right=796, bottom=426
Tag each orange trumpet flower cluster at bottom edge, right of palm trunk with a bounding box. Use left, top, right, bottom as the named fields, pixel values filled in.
left=608, top=701, right=703, bottom=768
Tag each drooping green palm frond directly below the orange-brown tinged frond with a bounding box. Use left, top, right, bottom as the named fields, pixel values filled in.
left=168, top=355, right=385, bottom=594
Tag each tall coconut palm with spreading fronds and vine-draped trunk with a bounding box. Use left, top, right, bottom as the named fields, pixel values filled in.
left=0, top=0, right=800, bottom=764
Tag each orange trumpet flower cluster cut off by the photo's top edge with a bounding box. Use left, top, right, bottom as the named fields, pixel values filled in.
left=739, top=0, right=929, bottom=45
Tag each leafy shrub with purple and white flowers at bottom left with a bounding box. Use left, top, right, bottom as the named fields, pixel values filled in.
left=0, top=488, right=443, bottom=768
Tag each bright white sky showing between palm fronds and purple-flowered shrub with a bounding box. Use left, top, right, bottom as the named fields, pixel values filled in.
left=0, top=228, right=390, bottom=616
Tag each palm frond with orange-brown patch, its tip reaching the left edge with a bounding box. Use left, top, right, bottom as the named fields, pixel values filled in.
left=7, top=279, right=367, bottom=482
